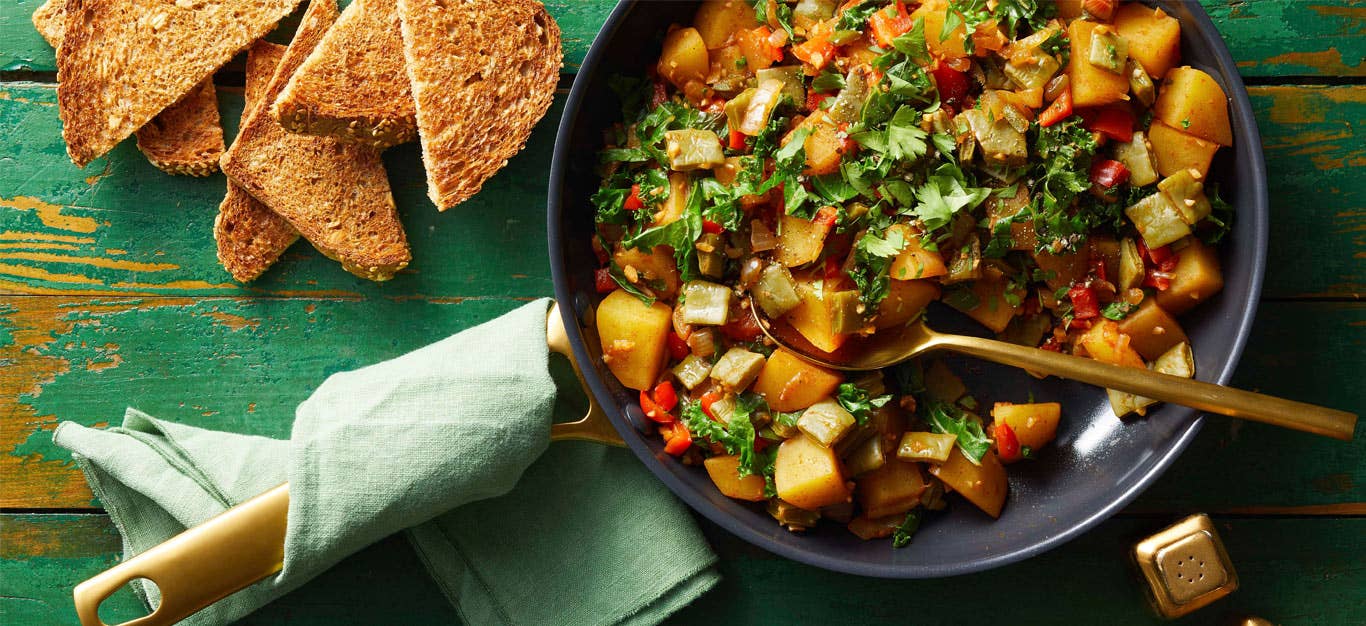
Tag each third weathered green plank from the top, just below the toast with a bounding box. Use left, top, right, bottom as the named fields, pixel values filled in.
left=0, top=297, right=1366, bottom=513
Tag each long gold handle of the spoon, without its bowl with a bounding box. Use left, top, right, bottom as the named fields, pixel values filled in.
left=926, top=334, right=1356, bottom=440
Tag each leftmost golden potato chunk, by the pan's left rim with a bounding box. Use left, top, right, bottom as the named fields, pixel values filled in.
left=597, top=290, right=673, bottom=390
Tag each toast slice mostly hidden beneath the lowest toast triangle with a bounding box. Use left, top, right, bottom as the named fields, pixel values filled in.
left=213, top=41, right=299, bottom=283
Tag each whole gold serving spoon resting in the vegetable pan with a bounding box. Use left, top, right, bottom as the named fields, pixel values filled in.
left=749, top=298, right=1356, bottom=440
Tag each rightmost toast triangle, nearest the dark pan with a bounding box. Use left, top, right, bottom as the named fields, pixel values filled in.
left=399, top=0, right=563, bottom=210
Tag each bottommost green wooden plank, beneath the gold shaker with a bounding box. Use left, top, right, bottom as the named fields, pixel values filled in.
left=0, top=514, right=1366, bottom=626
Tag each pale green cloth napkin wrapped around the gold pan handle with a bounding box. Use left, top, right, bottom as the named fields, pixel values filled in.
left=53, top=301, right=719, bottom=626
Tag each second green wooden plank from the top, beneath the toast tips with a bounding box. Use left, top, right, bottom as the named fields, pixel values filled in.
left=0, top=83, right=1366, bottom=298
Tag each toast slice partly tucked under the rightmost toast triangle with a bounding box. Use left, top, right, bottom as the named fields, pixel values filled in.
left=270, top=0, right=418, bottom=149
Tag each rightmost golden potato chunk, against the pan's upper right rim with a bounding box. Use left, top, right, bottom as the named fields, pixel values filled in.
left=1153, top=67, right=1233, bottom=146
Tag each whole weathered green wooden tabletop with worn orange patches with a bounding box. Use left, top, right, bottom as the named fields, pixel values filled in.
left=0, top=0, right=1366, bottom=625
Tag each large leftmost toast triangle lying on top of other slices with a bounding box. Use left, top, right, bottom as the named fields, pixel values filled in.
left=57, top=0, right=299, bottom=167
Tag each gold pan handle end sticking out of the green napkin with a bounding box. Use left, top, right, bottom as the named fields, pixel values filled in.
left=72, top=484, right=290, bottom=626
